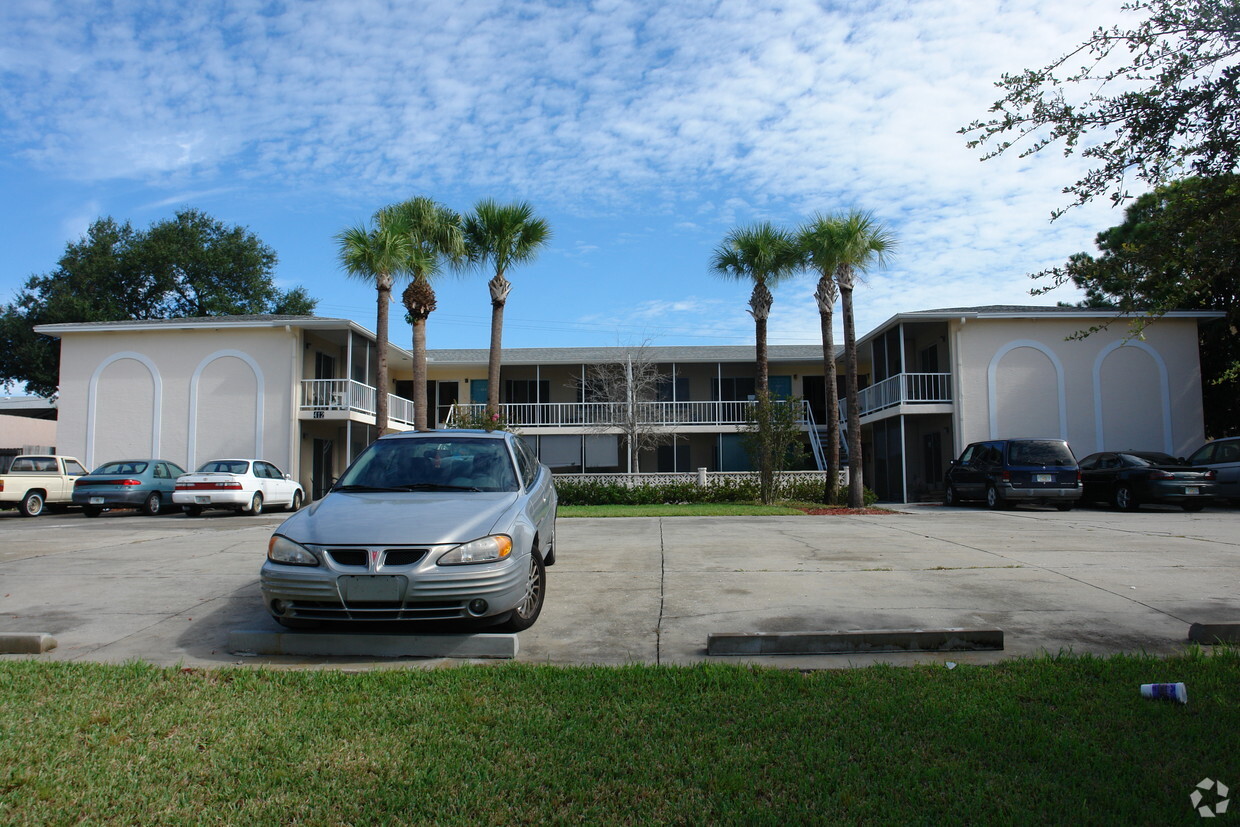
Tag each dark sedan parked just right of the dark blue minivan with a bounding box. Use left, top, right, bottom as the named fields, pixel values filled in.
left=1080, top=451, right=1218, bottom=511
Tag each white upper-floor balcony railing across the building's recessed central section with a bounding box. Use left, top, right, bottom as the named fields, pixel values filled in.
left=446, top=402, right=810, bottom=428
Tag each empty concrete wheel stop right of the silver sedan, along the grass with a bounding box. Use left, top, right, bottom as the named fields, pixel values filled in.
left=706, top=629, right=1003, bottom=656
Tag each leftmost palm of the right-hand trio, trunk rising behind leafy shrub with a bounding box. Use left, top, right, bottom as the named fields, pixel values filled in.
left=711, top=222, right=801, bottom=399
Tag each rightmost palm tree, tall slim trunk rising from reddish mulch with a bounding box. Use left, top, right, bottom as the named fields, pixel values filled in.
left=830, top=210, right=897, bottom=508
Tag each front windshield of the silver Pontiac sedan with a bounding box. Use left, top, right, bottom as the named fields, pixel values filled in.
left=336, top=436, right=517, bottom=491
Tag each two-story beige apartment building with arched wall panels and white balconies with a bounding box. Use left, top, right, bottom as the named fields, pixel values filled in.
left=37, top=307, right=1211, bottom=500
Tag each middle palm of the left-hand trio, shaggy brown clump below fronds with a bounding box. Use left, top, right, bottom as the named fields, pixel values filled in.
left=384, top=196, right=465, bottom=430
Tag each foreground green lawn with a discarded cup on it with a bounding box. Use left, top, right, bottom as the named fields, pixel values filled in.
left=0, top=650, right=1240, bottom=825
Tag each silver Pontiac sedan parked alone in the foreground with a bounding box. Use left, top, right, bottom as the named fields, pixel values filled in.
left=260, top=430, right=557, bottom=631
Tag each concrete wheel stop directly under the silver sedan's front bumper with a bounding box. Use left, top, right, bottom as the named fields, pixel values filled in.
left=228, top=630, right=518, bottom=658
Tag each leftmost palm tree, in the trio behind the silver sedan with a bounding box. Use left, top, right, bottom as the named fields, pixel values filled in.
left=336, top=211, right=409, bottom=436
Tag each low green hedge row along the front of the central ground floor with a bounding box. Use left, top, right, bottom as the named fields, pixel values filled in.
left=556, top=475, right=877, bottom=506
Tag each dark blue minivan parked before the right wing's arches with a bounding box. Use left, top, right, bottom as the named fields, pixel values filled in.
left=944, top=439, right=1081, bottom=511
